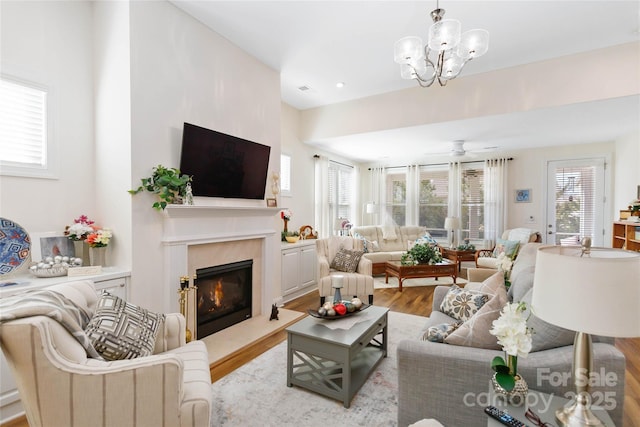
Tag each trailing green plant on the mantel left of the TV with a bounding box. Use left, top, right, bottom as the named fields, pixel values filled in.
left=129, top=165, right=192, bottom=211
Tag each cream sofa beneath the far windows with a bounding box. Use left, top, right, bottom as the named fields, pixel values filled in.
left=350, top=225, right=427, bottom=275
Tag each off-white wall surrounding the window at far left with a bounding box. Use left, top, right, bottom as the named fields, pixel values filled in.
left=0, top=1, right=96, bottom=251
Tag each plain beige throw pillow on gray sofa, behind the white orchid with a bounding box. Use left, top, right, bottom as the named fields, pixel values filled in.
left=444, top=272, right=507, bottom=350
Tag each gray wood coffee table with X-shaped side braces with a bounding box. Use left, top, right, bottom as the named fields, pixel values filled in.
left=286, top=306, right=389, bottom=408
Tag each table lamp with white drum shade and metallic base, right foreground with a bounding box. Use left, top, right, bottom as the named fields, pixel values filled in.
left=531, top=245, right=640, bottom=427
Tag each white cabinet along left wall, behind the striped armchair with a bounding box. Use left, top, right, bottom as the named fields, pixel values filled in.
left=0, top=267, right=130, bottom=424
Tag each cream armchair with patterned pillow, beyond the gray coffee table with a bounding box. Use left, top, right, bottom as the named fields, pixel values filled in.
left=316, top=236, right=373, bottom=305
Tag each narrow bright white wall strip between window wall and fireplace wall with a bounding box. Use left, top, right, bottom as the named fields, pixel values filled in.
left=93, top=2, right=133, bottom=269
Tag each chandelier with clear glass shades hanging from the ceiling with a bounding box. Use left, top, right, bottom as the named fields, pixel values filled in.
left=394, top=3, right=489, bottom=87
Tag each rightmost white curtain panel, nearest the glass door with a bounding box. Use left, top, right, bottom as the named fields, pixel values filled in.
left=484, top=158, right=509, bottom=248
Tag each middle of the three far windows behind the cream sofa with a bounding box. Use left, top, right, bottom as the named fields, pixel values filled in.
left=418, top=165, right=449, bottom=239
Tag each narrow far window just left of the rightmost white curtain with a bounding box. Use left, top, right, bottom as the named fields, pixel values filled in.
left=460, top=163, right=484, bottom=241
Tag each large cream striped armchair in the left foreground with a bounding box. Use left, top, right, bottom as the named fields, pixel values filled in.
left=0, top=281, right=211, bottom=427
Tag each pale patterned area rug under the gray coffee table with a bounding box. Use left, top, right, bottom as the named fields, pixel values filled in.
left=211, top=312, right=426, bottom=427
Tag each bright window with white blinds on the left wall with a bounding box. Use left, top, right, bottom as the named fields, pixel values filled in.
left=0, top=76, right=53, bottom=177
